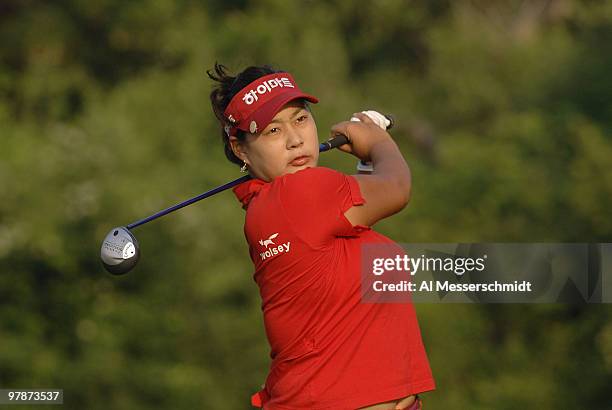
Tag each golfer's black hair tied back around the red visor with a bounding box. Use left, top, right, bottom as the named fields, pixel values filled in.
left=206, top=62, right=283, bottom=165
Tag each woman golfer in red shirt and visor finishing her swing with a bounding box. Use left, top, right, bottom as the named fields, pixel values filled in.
left=208, top=64, right=435, bottom=410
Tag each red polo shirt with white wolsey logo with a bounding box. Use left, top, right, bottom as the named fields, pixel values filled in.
left=234, top=167, right=435, bottom=410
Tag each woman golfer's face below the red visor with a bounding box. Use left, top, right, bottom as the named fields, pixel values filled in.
left=230, top=101, right=319, bottom=182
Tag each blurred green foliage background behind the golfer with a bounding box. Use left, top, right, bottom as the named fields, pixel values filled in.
left=0, top=0, right=612, bottom=410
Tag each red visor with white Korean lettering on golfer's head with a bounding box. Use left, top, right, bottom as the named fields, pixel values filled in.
left=224, top=73, right=319, bottom=135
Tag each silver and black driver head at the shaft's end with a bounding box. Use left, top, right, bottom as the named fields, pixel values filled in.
left=100, top=226, right=140, bottom=275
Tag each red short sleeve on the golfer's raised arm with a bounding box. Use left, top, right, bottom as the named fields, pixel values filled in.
left=280, top=167, right=369, bottom=247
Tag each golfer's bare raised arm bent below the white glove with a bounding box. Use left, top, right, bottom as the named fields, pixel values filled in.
left=332, top=114, right=411, bottom=226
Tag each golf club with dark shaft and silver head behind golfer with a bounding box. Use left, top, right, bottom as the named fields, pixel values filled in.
left=100, top=113, right=394, bottom=275
